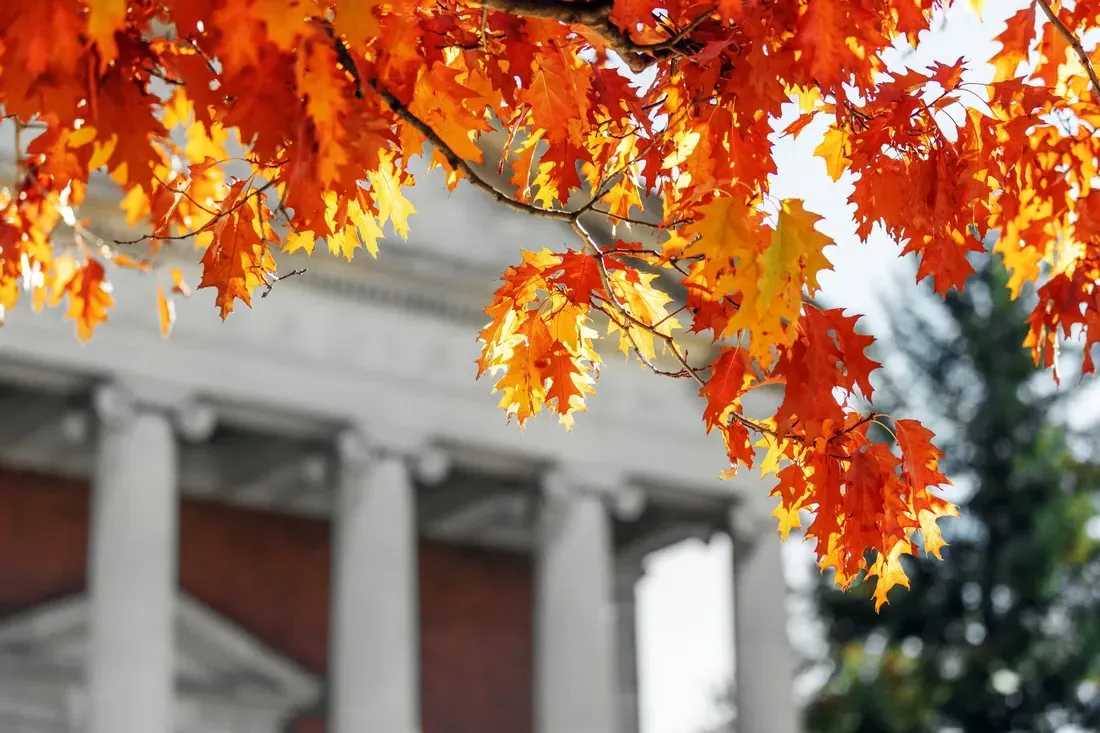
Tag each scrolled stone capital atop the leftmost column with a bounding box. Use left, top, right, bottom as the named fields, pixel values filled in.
left=91, top=380, right=218, bottom=442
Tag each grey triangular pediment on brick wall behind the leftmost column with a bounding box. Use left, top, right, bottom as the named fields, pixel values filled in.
left=0, top=594, right=320, bottom=710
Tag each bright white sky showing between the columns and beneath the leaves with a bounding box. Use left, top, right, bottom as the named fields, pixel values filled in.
left=638, top=5, right=1024, bottom=733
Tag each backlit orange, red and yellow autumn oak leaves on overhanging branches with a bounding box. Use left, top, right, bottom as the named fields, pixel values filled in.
left=0, top=0, right=1100, bottom=604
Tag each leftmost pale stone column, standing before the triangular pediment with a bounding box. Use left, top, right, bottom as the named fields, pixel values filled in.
left=87, top=378, right=213, bottom=733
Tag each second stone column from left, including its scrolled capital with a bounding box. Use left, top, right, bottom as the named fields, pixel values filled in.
left=329, top=430, right=447, bottom=733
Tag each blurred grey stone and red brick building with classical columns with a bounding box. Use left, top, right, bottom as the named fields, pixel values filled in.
left=0, top=143, right=796, bottom=733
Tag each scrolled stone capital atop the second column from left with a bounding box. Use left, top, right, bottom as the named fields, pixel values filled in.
left=336, top=425, right=451, bottom=485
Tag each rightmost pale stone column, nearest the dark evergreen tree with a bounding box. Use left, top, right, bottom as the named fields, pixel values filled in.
left=730, top=493, right=802, bottom=733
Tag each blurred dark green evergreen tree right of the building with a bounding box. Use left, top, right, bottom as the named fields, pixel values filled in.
left=805, top=256, right=1100, bottom=733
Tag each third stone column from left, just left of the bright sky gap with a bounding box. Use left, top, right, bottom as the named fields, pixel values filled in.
left=535, top=469, right=633, bottom=733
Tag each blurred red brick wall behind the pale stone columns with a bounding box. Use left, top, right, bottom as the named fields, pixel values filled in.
left=0, top=469, right=532, bottom=733
